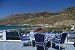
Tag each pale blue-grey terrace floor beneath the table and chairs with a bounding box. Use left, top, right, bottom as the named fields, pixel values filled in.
left=0, top=41, right=75, bottom=50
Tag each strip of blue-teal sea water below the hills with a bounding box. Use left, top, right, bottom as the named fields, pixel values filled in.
left=0, top=26, right=40, bottom=30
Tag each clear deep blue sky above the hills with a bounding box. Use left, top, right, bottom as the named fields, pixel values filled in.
left=0, top=0, right=75, bottom=18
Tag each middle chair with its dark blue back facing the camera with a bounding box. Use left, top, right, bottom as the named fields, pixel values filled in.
left=34, top=34, right=45, bottom=50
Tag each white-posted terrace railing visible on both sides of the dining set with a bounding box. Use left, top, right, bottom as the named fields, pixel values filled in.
left=0, top=31, right=75, bottom=43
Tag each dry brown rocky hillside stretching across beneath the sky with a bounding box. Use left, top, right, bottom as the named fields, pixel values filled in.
left=0, top=6, right=75, bottom=25
